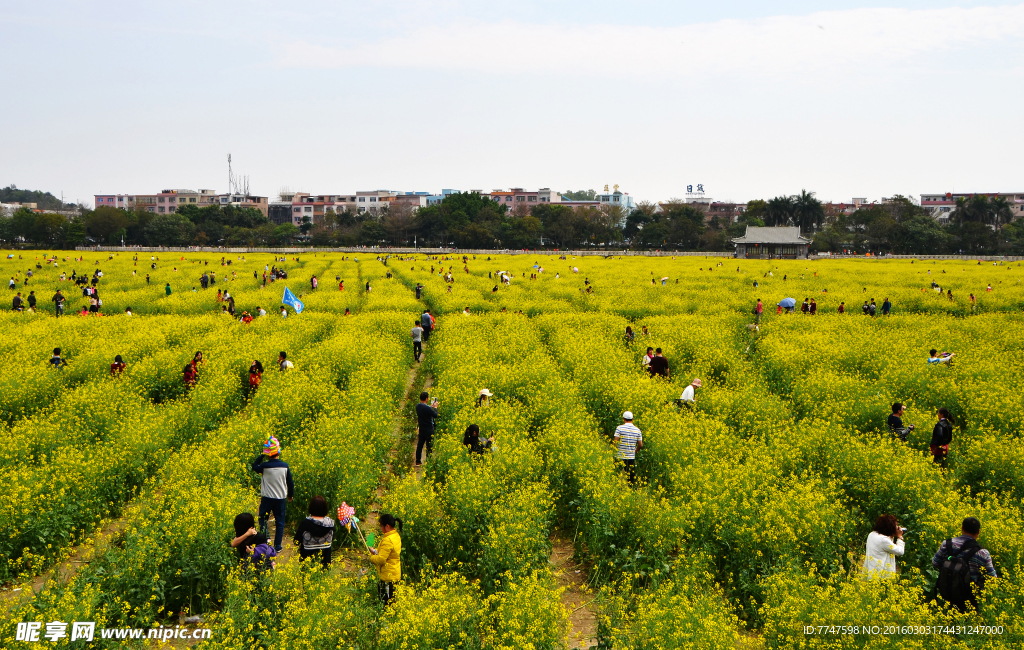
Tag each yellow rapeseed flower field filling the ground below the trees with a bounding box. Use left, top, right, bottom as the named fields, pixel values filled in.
left=0, top=250, right=1024, bottom=650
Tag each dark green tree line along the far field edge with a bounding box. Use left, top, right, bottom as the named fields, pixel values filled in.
left=0, top=190, right=1024, bottom=255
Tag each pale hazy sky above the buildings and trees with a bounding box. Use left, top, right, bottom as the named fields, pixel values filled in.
left=0, top=0, right=1024, bottom=205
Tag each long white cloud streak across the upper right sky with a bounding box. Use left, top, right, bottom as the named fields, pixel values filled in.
left=276, top=5, right=1024, bottom=78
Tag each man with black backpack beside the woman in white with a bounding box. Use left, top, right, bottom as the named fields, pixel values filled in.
left=932, top=517, right=998, bottom=612
